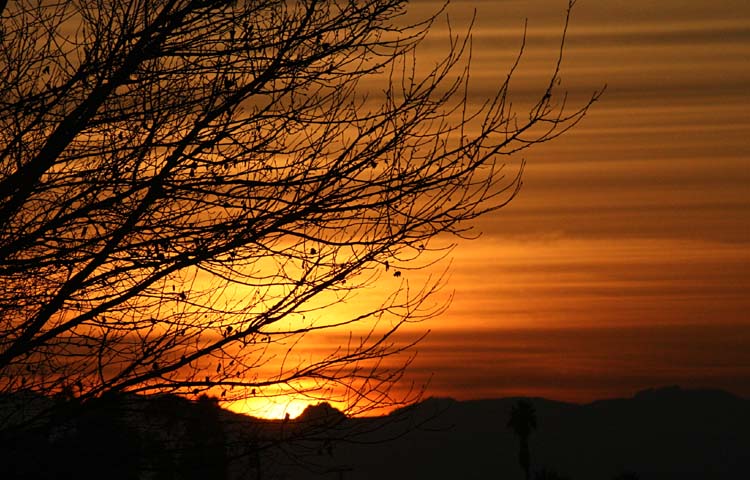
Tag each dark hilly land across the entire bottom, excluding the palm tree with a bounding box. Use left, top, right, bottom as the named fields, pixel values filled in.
left=0, top=387, right=750, bottom=480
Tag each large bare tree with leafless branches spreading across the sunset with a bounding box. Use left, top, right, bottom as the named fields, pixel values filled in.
left=0, top=0, right=598, bottom=424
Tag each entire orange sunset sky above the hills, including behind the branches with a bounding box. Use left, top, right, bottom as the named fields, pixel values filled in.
left=0, top=0, right=750, bottom=428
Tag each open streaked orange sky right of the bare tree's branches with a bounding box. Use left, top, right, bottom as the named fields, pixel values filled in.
left=236, top=0, right=750, bottom=413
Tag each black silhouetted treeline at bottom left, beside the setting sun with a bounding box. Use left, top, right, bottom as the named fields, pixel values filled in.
left=0, top=395, right=228, bottom=480
